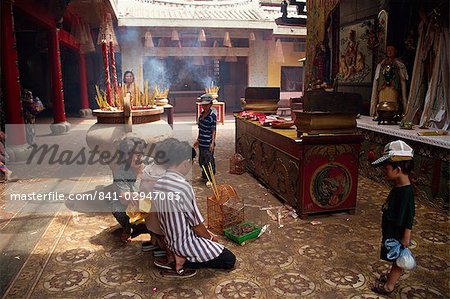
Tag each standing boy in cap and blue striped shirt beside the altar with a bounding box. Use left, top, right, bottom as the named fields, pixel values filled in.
left=194, top=94, right=217, bottom=186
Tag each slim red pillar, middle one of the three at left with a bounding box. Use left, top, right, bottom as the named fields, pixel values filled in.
left=49, top=28, right=66, bottom=123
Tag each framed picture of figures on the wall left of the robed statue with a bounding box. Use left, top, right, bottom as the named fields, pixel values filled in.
left=337, top=19, right=379, bottom=84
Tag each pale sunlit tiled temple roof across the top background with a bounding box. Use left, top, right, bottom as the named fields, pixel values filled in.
left=118, top=0, right=306, bottom=29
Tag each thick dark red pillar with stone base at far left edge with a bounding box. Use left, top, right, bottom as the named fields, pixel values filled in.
left=1, top=0, right=26, bottom=145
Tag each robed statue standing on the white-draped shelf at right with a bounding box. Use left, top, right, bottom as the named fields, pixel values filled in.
left=370, top=46, right=408, bottom=123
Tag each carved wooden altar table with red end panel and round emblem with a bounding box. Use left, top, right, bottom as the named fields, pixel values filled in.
left=236, top=116, right=363, bottom=218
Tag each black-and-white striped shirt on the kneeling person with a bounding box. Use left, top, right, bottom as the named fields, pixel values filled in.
left=154, top=170, right=224, bottom=263
